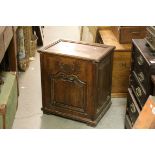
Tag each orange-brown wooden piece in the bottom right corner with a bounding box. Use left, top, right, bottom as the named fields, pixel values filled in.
left=133, top=95, right=155, bottom=129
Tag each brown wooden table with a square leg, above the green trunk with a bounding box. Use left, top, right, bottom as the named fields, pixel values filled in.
left=0, top=26, right=18, bottom=72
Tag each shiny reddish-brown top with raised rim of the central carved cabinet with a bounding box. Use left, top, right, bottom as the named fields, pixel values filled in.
left=39, top=40, right=115, bottom=61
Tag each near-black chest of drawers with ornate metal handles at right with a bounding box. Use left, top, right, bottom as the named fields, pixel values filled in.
left=126, top=39, right=155, bottom=128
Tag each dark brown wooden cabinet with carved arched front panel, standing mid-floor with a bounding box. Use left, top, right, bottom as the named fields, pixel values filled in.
left=39, top=40, right=114, bottom=126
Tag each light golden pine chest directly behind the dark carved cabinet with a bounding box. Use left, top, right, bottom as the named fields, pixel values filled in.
left=99, top=29, right=131, bottom=97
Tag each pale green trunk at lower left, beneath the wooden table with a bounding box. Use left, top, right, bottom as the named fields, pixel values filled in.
left=0, top=72, right=17, bottom=128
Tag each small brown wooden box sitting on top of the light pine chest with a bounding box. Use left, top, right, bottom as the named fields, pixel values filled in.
left=111, top=26, right=146, bottom=44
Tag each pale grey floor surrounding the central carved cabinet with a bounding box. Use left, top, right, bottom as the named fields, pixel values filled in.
left=13, top=27, right=126, bottom=129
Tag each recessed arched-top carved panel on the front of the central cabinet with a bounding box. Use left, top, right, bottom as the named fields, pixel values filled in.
left=50, top=72, right=86, bottom=113
